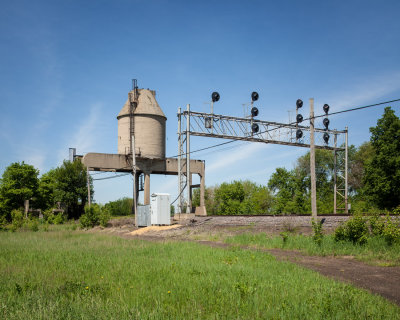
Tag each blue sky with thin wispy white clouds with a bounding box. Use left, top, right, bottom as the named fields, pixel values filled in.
left=0, top=0, right=400, bottom=203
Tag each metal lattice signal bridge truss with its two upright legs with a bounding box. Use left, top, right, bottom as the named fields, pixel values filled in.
left=178, top=105, right=348, bottom=213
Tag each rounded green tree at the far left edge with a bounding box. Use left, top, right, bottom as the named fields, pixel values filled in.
left=0, top=161, right=39, bottom=221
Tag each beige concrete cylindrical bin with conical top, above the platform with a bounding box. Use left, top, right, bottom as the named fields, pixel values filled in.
left=117, top=89, right=167, bottom=159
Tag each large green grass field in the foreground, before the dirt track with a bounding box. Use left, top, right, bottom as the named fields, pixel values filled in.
left=0, top=227, right=400, bottom=319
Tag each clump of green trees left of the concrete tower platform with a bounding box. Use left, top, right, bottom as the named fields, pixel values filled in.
left=0, top=161, right=94, bottom=223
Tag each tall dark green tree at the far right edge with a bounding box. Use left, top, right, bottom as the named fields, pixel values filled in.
left=363, top=107, right=400, bottom=210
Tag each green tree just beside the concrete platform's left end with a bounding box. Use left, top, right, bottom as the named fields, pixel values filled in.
left=54, top=161, right=94, bottom=218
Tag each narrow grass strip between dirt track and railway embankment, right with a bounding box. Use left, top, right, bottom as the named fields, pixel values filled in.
left=225, top=233, right=400, bottom=266
